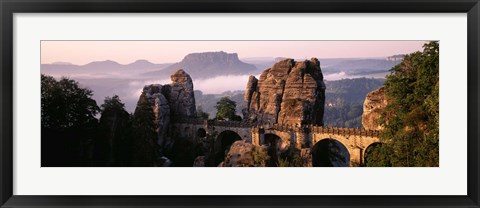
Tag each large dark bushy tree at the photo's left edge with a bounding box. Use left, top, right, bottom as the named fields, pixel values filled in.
left=41, top=74, right=100, bottom=166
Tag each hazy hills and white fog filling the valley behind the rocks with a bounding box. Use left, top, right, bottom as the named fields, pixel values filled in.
left=41, top=51, right=400, bottom=112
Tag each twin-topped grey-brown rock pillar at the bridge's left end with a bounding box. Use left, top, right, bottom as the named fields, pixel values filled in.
left=137, top=69, right=196, bottom=147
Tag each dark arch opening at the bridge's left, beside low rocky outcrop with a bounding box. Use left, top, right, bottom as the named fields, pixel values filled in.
left=214, top=130, right=242, bottom=165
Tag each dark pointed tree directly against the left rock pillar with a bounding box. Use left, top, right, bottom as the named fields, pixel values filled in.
left=132, top=92, right=157, bottom=167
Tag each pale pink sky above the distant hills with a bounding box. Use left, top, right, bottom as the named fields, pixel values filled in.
left=41, top=41, right=425, bottom=65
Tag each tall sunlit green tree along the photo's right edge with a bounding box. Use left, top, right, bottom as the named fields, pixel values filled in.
left=367, top=41, right=439, bottom=167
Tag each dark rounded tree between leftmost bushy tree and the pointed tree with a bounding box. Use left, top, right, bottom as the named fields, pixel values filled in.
left=95, top=95, right=132, bottom=166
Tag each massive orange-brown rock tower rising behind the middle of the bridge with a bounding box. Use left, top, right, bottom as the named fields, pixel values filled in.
left=244, top=58, right=325, bottom=126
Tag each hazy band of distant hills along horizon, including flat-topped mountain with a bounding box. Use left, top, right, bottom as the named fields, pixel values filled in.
left=41, top=55, right=400, bottom=80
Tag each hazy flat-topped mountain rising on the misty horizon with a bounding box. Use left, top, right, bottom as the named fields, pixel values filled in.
left=144, top=51, right=257, bottom=79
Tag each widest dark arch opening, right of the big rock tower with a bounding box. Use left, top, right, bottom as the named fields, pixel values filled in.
left=312, top=138, right=350, bottom=167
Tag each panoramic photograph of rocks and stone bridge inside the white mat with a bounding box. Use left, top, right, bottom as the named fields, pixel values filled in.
left=39, top=40, right=440, bottom=168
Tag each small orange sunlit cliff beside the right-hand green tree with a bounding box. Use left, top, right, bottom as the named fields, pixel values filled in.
left=362, top=87, right=387, bottom=130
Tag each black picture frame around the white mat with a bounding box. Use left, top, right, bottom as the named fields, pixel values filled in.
left=0, top=0, right=480, bottom=207
